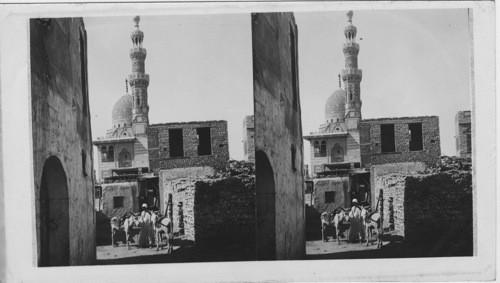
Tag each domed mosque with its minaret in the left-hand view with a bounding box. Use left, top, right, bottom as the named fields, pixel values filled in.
left=94, top=17, right=149, bottom=180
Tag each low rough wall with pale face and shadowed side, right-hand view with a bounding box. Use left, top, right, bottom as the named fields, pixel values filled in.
left=377, top=171, right=473, bottom=245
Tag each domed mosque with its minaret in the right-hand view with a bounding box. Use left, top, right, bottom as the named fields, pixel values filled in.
left=304, top=11, right=363, bottom=178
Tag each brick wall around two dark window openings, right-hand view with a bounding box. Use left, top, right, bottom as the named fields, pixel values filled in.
left=359, top=116, right=441, bottom=168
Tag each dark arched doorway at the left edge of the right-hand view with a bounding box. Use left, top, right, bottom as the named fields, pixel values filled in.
left=255, top=150, right=276, bottom=260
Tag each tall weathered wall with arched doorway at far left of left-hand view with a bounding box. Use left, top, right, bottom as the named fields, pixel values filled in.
left=30, top=18, right=96, bottom=266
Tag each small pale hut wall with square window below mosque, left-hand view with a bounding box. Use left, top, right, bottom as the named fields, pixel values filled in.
left=101, top=182, right=139, bottom=218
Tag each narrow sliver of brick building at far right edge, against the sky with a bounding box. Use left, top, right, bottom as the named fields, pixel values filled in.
left=455, top=111, right=472, bottom=157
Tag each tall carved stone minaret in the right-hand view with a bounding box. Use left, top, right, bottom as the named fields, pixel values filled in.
left=342, top=11, right=363, bottom=129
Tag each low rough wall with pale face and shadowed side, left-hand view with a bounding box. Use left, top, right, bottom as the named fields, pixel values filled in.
left=160, top=167, right=256, bottom=248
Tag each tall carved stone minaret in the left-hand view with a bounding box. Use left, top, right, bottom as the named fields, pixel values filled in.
left=128, top=16, right=149, bottom=135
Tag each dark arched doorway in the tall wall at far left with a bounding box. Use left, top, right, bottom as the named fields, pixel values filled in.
left=39, top=156, right=69, bottom=266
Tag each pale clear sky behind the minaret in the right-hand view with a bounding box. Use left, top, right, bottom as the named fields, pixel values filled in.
left=295, top=9, right=471, bottom=169
